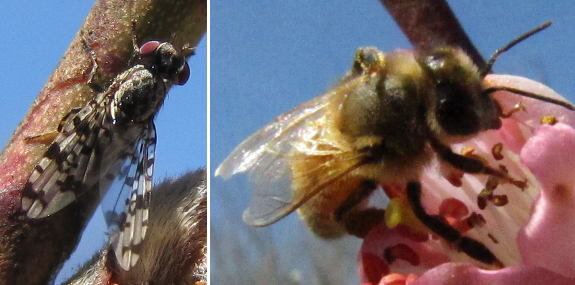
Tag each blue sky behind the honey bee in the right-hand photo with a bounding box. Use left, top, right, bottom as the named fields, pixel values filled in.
left=214, top=0, right=575, bottom=284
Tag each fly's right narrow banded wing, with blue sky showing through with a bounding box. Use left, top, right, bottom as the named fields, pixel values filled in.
left=108, top=122, right=156, bottom=270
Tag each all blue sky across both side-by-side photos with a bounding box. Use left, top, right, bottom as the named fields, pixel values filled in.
left=0, top=0, right=575, bottom=284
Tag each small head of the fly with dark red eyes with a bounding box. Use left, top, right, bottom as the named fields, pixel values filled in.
left=139, top=41, right=195, bottom=85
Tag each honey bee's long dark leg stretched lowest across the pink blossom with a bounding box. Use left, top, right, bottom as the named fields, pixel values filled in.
left=407, top=182, right=503, bottom=267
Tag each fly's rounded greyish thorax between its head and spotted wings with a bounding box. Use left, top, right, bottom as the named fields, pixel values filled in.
left=110, top=65, right=171, bottom=124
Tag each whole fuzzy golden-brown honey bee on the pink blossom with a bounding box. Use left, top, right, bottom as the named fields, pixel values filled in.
left=215, top=22, right=575, bottom=265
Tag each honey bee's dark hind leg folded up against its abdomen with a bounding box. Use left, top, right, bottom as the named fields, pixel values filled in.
left=335, top=180, right=385, bottom=238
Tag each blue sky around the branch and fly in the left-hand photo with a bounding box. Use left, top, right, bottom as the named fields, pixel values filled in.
left=0, top=0, right=207, bottom=284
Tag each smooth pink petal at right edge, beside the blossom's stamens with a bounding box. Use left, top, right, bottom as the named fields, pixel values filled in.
left=517, top=123, right=575, bottom=278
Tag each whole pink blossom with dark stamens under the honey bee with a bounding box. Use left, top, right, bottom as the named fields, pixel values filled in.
left=359, top=75, right=575, bottom=284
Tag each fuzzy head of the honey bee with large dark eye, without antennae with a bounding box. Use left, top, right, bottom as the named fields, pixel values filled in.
left=417, top=47, right=500, bottom=141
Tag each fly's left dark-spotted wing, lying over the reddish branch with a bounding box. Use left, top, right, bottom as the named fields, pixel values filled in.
left=22, top=93, right=110, bottom=218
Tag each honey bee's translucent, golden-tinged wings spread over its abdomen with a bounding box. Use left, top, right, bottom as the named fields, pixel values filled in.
left=215, top=77, right=362, bottom=226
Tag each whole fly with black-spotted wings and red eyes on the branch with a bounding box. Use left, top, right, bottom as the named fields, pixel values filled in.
left=22, top=38, right=194, bottom=270
